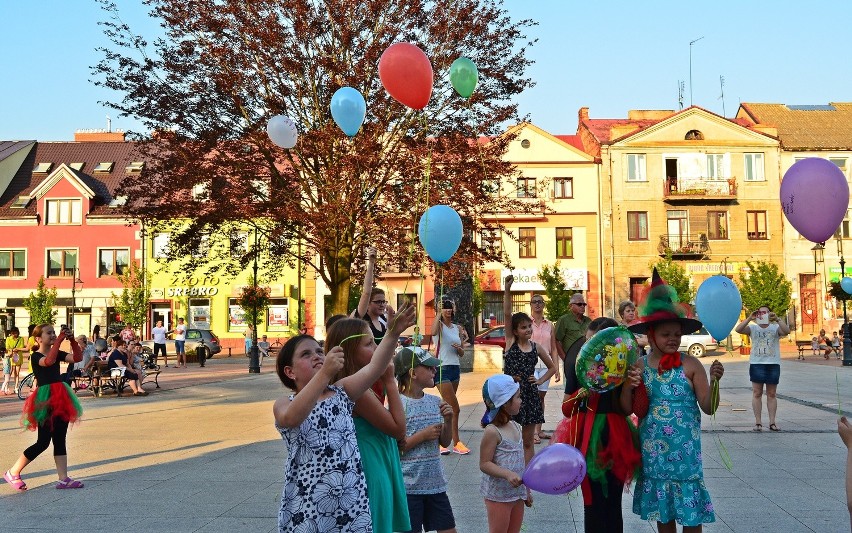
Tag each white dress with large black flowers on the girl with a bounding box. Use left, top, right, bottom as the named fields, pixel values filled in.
left=275, top=385, right=373, bottom=533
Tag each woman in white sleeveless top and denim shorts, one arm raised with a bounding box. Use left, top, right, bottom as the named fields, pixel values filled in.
left=432, top=298, right=470, bottom=455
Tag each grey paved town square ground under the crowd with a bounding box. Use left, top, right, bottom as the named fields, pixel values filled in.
left=0, top=353, right=852, bottom=533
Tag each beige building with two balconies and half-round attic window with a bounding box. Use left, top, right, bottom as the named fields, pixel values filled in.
left=578, top=106, right=783, bottom=316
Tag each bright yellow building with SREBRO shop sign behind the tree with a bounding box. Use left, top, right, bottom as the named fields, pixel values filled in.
left=143, top=225, right=306, bottom=353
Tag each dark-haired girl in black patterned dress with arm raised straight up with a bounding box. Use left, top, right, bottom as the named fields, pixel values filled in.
left=503, top=274, right=556, bottom=463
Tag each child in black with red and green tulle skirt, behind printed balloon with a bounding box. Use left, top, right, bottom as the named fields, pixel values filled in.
left=553, top=317, right=642, bottom=533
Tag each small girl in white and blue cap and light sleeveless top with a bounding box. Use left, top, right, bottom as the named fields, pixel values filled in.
left=479, top=374, right=532, bottom=533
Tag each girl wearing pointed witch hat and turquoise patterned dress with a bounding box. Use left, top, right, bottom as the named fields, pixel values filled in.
left=620, top=269, right=724, bottom=533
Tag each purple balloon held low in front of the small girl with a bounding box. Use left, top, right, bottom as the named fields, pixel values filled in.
left=524, top=443, right=586, bottom=494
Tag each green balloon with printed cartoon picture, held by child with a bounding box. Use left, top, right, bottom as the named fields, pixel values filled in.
left=576, top=326, right=639, bottom=392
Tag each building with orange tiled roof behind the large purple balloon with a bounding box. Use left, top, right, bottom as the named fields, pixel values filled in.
left=737, top=103, right=852, bottom=335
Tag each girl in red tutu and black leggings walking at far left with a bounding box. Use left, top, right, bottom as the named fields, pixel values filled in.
left=3, top=324, right=83, bottom=490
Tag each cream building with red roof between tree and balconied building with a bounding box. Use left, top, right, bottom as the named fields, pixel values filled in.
left=481, top=124, right=603, bottom=323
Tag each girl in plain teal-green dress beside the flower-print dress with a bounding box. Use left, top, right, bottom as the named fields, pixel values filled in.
left=325, top=318, right=411, bottom=533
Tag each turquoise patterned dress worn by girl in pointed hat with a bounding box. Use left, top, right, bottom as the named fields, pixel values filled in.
left=633, top=357, right=716, bottom=526
